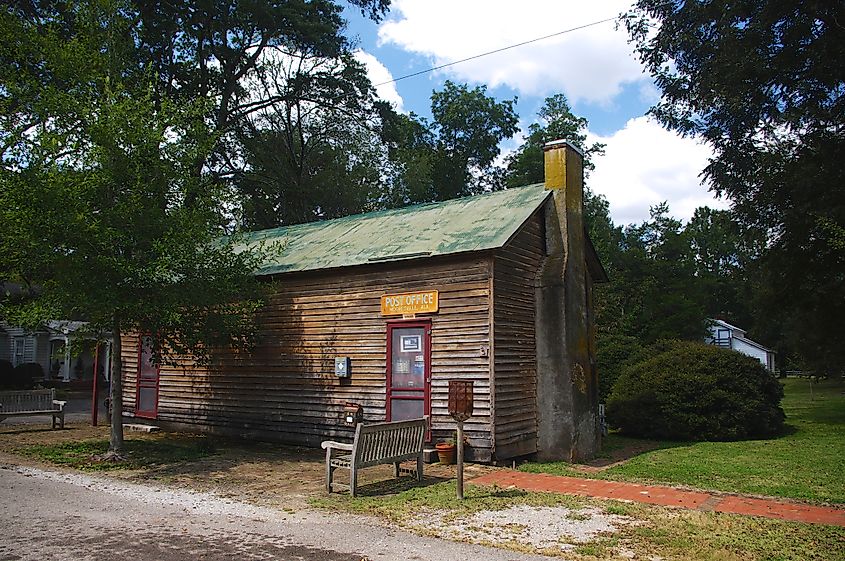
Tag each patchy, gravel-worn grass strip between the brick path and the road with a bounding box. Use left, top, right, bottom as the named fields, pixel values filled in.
left=311, top=478, right=845, bottom=561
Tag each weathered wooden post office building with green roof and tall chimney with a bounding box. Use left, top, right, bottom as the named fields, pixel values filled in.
left=122, top=142, right=605, bottom=462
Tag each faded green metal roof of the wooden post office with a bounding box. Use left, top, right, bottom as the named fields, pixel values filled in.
left=237, top=183, right=550, bottom=275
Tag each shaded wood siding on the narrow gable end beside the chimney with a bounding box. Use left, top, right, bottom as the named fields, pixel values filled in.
left=493, top=211, right=545, bottom=460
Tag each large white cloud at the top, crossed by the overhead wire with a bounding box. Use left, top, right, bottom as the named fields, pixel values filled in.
left=379, top=0, right=644, bottom=104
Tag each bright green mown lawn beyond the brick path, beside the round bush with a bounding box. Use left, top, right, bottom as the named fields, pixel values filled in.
left=521, top=378, right=845, bottom=504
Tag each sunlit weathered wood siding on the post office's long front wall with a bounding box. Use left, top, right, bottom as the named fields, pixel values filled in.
left=118, top=254, right=492, bottom=461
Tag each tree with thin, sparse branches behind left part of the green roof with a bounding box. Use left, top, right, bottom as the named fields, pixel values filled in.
left=235, top=52, right=387, bottom=229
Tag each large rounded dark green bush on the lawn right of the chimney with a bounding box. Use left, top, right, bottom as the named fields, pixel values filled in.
left=607, top=341, right=784, bottom=440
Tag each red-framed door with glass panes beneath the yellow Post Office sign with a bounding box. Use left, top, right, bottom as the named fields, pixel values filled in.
left=387, top=321, right=431, bottom=421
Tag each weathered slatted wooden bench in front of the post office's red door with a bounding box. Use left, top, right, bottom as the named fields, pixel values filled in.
left=322, top=419, right=427, bottom=497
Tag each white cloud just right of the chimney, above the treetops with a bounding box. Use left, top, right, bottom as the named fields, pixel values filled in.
left=588, top=117, right=729, bottom=225
